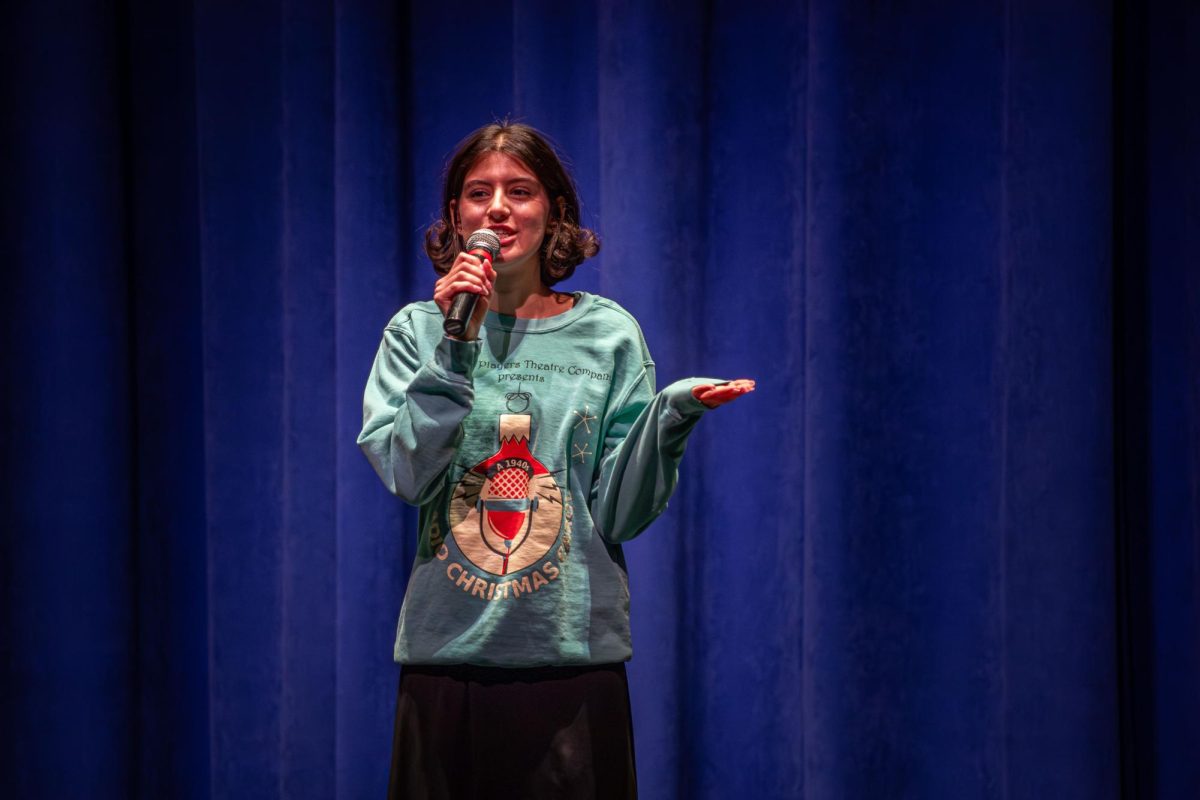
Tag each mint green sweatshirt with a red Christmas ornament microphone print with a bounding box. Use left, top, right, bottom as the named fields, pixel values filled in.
left=359, top=293, right=716, bottom=667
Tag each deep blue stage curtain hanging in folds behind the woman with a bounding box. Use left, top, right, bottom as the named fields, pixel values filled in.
left=0, top=0, right=1200, bottom=800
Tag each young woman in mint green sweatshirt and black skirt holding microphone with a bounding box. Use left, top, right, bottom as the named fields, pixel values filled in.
left=359, top=124, right=754, bottom=799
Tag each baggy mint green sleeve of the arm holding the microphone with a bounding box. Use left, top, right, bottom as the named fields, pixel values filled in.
left=358, top=325, right=481, bottom=505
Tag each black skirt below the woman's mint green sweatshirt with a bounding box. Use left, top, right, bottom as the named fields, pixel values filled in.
left=388, top=663, right=637, bottom=800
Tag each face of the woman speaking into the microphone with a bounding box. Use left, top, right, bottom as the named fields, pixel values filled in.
left=450, top=152, right=550, bottom=275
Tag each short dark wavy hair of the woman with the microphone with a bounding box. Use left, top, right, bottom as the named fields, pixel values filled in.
left=425, top=120, right=600, bottom=287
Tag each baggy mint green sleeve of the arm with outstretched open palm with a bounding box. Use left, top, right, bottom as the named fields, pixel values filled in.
left=592, top=363, right=720, bottom=543
